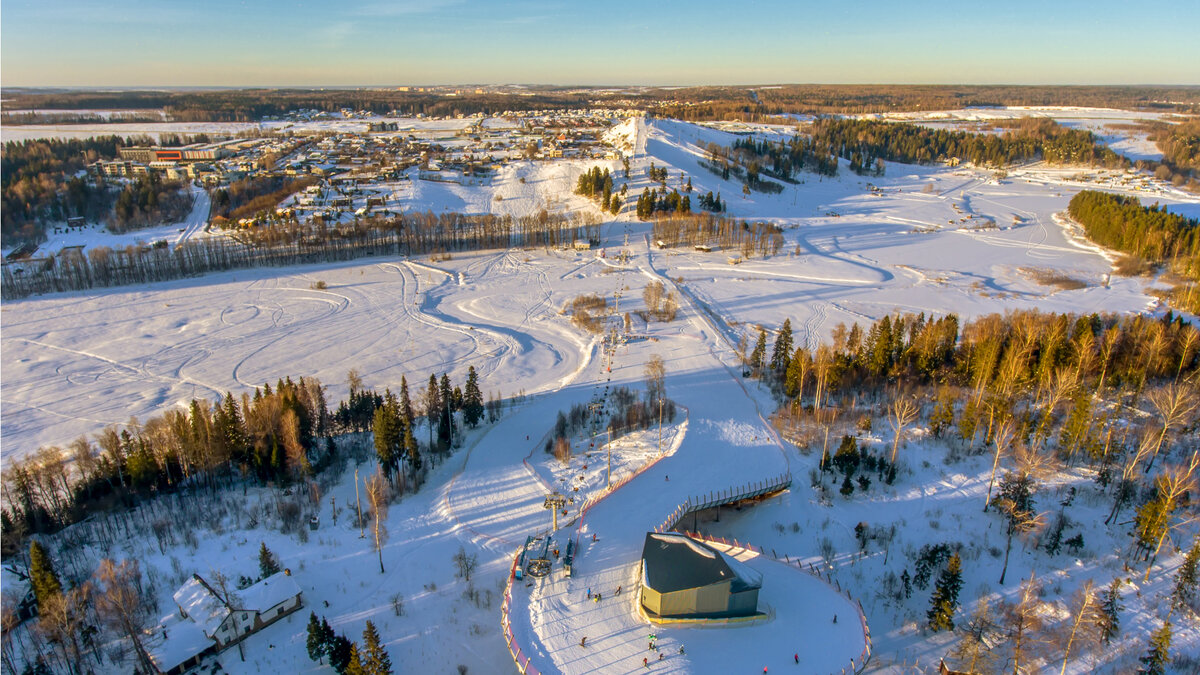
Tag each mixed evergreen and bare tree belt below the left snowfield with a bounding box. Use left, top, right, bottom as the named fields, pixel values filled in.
left=0, top=366, right=500, bottom=556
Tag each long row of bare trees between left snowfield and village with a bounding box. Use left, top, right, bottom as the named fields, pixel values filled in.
left=0, top=210, right=599, bottom=300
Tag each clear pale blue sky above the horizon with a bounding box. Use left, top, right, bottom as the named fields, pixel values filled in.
left=0, top=0, right=1200, bottom=86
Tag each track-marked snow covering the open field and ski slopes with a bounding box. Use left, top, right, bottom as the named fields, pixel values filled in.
left=0, top=112, right=1200, bottom=674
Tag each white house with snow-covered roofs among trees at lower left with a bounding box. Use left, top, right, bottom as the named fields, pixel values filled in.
left=148, top=571, right=302, bottom=675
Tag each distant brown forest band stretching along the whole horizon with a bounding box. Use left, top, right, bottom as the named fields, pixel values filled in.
left=5, top=84, right=1200, bottom=121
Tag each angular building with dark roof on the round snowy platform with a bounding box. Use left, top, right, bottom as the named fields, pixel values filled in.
left=642, top=532, right=762, bottom=619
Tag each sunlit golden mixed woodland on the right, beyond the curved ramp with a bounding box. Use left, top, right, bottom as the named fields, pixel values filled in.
left=742, top=311, right=1200, bottom=671
